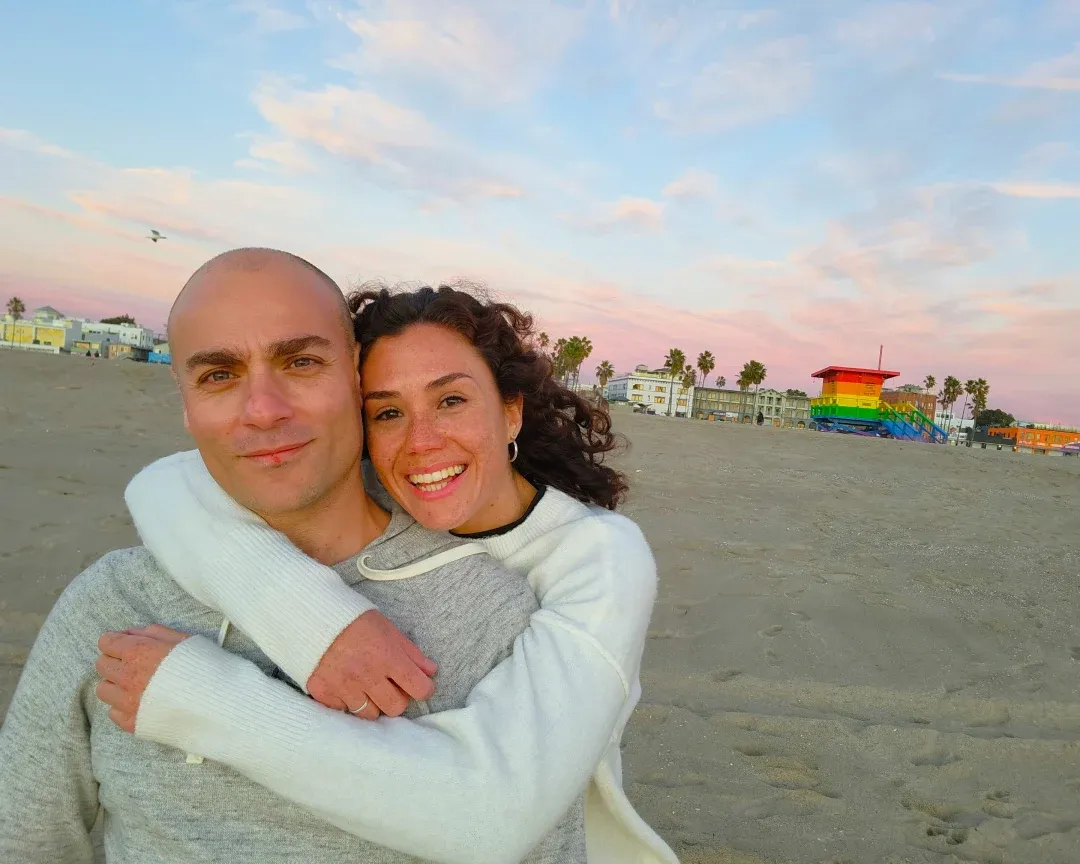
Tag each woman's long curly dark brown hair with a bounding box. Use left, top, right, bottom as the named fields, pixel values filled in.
left=349, top=283, right=629, bottom=510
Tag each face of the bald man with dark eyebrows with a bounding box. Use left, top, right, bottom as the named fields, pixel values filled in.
left=170, top=259, right=363, bottom=522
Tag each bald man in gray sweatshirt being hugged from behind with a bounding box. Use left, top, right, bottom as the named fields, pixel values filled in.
left=0, top=249, right=584, bottom=864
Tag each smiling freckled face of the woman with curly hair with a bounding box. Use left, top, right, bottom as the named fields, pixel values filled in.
left=360, top=324, right=522, bottom=532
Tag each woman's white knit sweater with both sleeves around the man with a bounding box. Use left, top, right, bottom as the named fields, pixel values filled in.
left=126, top=451, right=677, bottom=864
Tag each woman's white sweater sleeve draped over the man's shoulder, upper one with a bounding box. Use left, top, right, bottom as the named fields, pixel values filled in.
left=124, top=450, right=376, bottom=687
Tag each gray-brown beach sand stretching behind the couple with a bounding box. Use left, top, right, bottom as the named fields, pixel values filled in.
left=0, top=350, right=1080, bottom=864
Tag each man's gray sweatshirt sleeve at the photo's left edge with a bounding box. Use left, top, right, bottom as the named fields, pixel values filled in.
left=0, top=584, right=98, bottom=864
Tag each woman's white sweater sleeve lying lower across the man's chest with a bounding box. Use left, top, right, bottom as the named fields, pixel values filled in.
left=136, top=609, right=625, bottom=864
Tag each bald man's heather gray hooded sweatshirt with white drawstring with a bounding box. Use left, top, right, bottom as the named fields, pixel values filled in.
left=0, top=510, right=585, bottom=864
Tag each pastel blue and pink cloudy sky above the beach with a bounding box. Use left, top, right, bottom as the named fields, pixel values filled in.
left=0, top=0, right=1080, bottom=423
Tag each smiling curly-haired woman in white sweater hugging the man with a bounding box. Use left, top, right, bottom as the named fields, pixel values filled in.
left=120, top=285, right=677, bottom=864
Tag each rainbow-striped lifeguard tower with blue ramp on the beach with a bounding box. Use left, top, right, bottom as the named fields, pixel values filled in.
left=810, top=366, right=948, bottom=444
